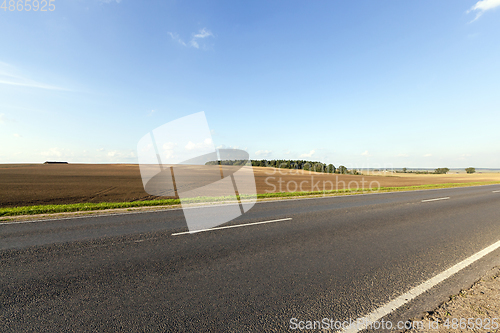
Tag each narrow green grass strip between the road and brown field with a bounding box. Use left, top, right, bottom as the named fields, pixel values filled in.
left=0, top=182, right=500, bottom=217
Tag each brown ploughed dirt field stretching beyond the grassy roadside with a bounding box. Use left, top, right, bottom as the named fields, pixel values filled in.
left=0, top=164, right=500, bottom=207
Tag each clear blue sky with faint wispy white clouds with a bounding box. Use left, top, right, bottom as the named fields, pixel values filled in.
left=0, top=0, right=500, bottom=168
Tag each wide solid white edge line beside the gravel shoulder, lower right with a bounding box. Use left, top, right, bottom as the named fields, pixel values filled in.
left=338, top=237, right=500, bottom=332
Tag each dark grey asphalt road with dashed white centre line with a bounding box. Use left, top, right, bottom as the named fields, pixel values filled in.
left=0, top=185, right=500, bottom=332
